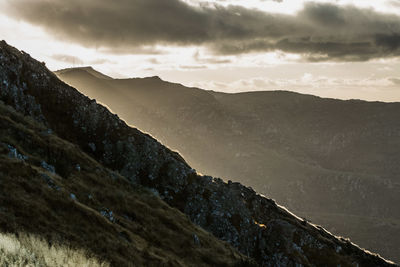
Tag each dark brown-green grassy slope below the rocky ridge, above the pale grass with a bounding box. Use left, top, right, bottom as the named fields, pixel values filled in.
left=0, top=101, right=250, bottom=266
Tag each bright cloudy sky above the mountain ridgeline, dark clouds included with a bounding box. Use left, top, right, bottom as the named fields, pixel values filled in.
left=0, top=0, right=400, bottom=102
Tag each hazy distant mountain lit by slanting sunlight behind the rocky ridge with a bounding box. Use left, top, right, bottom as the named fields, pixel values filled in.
left=56, top=65, right=400, bottom=261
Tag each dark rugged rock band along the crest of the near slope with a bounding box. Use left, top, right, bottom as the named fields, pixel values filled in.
left=0, top=42, right=391, bottom=266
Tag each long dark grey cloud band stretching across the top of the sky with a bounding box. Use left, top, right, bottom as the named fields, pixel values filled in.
left=7, top=0, right=400, bottom=61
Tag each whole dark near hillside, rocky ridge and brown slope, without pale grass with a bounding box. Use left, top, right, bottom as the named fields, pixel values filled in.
left=0, top=41, right=395, bottom=266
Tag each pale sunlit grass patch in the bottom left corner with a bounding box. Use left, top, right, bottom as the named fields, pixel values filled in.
left=0, top=234, right=110, bottom=267
